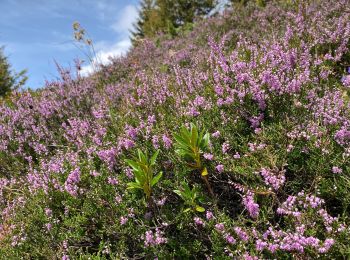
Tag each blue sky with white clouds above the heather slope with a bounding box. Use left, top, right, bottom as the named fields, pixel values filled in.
left=0, top=0, right=139, bottom=89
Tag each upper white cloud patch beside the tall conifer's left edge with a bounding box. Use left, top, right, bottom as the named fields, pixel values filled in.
left=111, top=5, right=138, bottom=33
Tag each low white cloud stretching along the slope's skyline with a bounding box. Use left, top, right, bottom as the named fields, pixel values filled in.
left=81, top=38, right=131, bottom=76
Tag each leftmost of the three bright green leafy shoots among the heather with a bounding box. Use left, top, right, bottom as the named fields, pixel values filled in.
left=125, top=149, right=163, bottom=202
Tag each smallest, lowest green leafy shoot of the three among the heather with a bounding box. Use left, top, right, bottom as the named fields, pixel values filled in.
left=174, top=182, right=205, bottom=212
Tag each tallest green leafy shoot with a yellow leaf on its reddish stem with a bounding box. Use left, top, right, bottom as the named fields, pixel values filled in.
left=174, top=123, right=213, bottom=195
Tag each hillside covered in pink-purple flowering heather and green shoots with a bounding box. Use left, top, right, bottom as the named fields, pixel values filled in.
left=0, top=0, right=350, bottom=259
